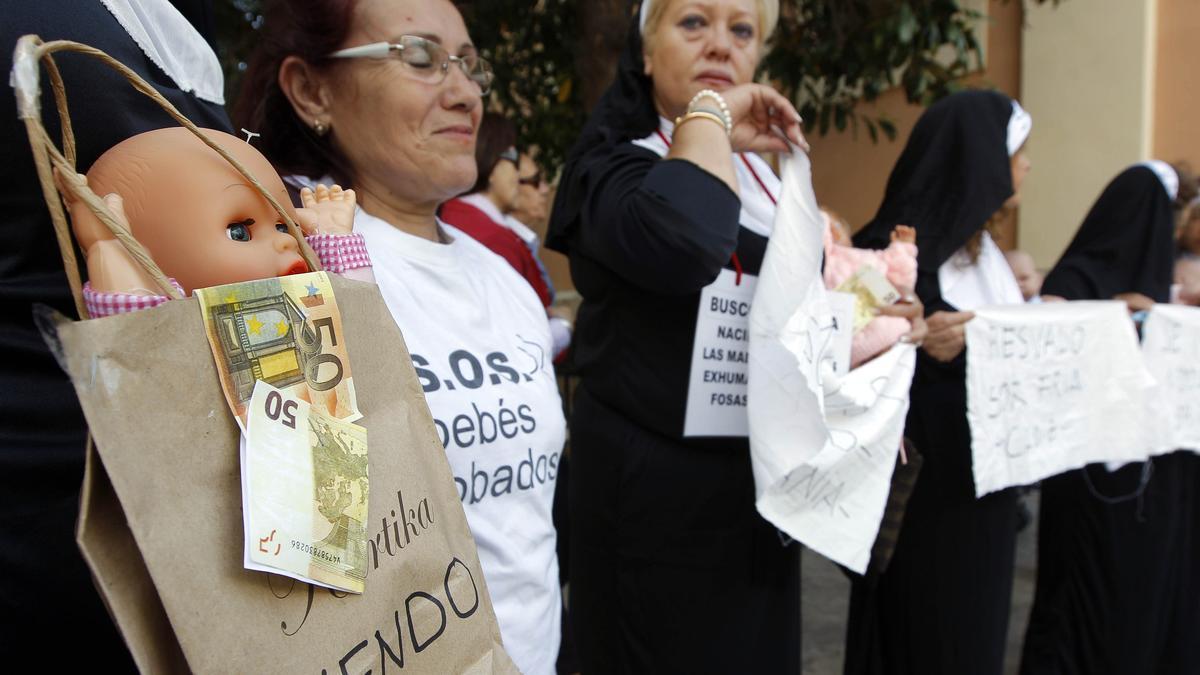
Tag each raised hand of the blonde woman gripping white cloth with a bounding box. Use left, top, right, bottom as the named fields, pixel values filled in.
left=721, top=84, right=809, bottom=153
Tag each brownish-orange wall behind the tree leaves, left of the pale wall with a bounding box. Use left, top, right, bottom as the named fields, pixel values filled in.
left=809, top=0, right=1022, bottom=247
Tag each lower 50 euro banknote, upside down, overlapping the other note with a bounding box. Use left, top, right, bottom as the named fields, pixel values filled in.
left=241, top=381, right=370, bottom=593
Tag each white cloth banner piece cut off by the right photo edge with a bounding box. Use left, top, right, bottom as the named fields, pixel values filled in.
left=1141, top=300, right=1200, bottom=452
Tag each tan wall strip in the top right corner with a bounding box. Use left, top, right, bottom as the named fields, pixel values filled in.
left=1152, top=0, right=1200, bottom=169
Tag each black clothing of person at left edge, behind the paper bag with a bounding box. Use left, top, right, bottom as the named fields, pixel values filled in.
left=0, top=0, right=232, bottom=670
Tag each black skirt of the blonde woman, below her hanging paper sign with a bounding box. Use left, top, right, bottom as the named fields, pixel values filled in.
left=570, top=386, right=800, bottom=674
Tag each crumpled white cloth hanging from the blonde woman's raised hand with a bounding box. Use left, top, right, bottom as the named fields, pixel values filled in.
left=748, top=151, right=916, bottom=573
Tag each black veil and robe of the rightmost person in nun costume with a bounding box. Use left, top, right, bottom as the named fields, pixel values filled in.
left=1021, top=166, right=1200, bottom=675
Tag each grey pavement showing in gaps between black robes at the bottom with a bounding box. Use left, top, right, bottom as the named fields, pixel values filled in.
left=800, top=492, right=1038, bottom=675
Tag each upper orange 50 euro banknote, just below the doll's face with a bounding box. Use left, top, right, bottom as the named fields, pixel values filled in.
left=196, top=271, right=362, bottom=432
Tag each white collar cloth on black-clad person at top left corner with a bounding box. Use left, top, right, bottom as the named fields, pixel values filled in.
left=101, top=0, right=224, bottom=106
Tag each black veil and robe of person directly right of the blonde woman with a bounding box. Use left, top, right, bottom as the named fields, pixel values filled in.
left=845, top=91, right=1016, bottom=675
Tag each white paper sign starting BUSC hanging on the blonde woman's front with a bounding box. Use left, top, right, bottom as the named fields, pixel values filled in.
left=683, top=269, right=757, bottom=436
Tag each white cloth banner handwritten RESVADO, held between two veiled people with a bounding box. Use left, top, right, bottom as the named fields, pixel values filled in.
left=966, top=300, right=1166, bottom=496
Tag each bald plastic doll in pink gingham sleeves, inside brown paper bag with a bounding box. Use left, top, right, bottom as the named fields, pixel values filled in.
left=59, top=127, right=373, bottom=317
